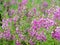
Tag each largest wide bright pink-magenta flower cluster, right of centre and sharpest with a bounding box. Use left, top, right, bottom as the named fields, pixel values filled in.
left=32, top=18, right=55, bottom=30
